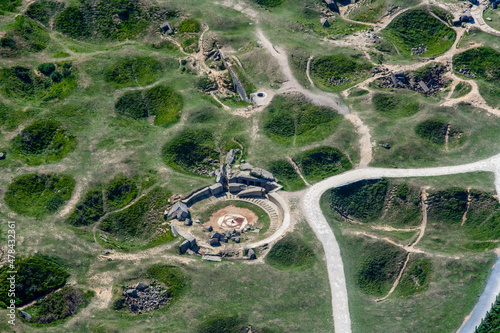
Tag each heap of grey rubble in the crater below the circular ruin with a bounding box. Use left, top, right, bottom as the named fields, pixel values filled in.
left=118, top=281, right=171, bottom=314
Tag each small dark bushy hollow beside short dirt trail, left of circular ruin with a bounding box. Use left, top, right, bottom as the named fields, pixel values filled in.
left=66, top=188, right=104, bottom=227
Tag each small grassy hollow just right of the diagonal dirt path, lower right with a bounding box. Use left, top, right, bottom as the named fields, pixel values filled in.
left=395, top=257, right=432, bottom=297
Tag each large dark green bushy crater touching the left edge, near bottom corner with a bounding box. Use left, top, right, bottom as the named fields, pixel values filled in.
left=0, top=254, right=69, bottom=306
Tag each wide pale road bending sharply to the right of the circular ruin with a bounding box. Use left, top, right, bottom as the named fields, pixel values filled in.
left=302, top=154, right=500, bottom=333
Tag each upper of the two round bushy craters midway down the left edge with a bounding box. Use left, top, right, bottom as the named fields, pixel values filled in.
left=12, top=120, right=76, bottom=164
